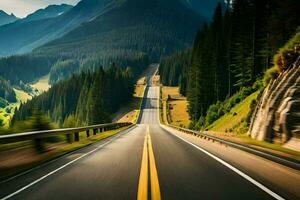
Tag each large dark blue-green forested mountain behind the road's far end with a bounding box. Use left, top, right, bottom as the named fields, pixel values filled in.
left=0, top=0, right=205, bottom=84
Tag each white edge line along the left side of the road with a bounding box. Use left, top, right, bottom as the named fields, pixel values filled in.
left=1, top=128, right=137, bottom=200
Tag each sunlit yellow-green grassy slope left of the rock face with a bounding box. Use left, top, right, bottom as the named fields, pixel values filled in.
left=208, top=92, right=259, bottom=132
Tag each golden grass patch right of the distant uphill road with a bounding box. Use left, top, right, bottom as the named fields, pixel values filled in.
left=162, top=87, right=190, bottom=127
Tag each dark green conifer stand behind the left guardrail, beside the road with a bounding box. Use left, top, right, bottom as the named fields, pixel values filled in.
left=11, top=66, right=134, bottom=127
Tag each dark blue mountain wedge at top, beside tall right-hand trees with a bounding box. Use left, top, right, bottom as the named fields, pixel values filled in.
left=182, top=0, right=226, bottom=19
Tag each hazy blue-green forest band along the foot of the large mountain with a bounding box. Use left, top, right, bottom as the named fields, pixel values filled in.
left=0, top=50, right=149, bottom=86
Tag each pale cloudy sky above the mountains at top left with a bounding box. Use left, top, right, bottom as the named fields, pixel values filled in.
left=0, top=0, right=80, bottom=18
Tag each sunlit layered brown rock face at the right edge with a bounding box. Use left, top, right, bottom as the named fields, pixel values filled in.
left=249, top=58, right=300, bottom=144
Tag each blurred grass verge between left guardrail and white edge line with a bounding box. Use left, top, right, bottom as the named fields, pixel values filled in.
left=0, top=127, right=128, bottom=179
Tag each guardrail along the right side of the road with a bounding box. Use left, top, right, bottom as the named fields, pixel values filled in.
left=167, top=125, right=300, bottom=170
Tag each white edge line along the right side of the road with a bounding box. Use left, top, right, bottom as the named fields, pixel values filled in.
left=162, top=127, right=285, bottom=200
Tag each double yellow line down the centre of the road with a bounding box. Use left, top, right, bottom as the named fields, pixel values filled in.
left=137, top=125, right=161, bottom=200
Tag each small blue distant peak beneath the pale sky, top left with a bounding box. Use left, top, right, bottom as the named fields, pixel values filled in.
left=22, top=4, right=73, bottom=22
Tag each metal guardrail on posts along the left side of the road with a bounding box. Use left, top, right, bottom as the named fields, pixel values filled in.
left=0, top=123, right=132, bottom=143
